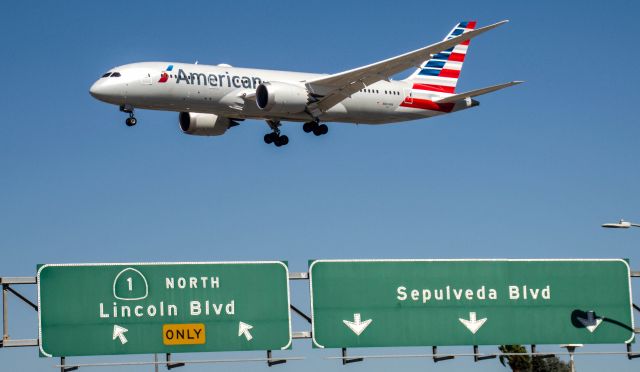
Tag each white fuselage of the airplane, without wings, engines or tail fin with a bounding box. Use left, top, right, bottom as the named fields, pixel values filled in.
left=90, top=62, right=468, bottom=124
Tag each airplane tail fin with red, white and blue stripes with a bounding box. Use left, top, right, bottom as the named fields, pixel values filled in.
left=405, top=21, right=476, bottom=94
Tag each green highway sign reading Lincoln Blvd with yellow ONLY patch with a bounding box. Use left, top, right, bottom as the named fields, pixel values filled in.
left=37, top=261, right=291, bottom=357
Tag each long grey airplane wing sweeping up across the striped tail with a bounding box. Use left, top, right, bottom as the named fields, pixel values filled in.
left=305, top=20, right=509, bottom=116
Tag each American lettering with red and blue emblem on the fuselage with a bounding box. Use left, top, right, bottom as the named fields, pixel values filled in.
left=158, top=65, right=262, bottom=89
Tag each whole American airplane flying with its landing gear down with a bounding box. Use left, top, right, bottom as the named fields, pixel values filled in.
left=89, top=20, right=522, bottom=147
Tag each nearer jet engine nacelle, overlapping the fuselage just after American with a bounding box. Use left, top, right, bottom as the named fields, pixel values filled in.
left=256, top=81, right=308, bottom=114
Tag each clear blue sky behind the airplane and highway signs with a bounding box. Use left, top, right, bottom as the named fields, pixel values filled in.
left=0, top=1, right=640, bottom=371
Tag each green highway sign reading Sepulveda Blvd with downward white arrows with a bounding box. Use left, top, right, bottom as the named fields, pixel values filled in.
left=309, top=260, right=634, bottom=348
